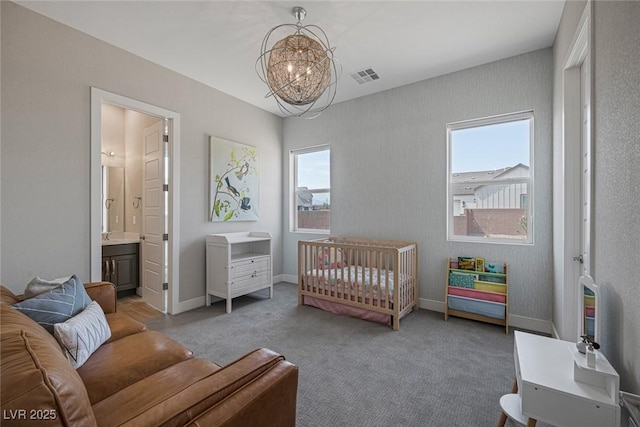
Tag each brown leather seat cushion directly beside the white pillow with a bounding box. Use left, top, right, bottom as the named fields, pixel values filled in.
left=77, top=331, right=193, bottom=405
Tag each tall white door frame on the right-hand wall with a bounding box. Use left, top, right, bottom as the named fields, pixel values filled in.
left=557, top=0, right=594, bottom=341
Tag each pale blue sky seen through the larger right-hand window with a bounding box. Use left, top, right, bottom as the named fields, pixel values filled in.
left=451, top=119, right=531, bottom=173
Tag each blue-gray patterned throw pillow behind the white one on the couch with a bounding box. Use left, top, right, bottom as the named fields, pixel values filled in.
left=13, top=274, right=91, bottom=333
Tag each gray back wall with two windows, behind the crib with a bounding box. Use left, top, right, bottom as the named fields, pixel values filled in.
left=283, top=49, right=552, bottom=329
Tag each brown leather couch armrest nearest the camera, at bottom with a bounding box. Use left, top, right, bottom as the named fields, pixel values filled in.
left=102, top=348, right=298, bottom=427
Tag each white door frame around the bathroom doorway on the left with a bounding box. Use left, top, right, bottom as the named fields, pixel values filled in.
left=89, top=87, right=180, bottom=314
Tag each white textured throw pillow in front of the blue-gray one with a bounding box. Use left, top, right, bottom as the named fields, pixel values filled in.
left=53, top=301, right=111, bottom=369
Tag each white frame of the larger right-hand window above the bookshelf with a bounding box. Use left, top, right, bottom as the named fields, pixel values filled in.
left=446, top=110, right=535, bottom=246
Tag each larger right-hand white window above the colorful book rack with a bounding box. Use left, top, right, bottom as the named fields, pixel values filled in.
left=447, top=111, right=533, bottom=244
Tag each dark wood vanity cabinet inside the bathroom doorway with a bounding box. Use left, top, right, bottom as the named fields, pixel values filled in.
left=102, top=243, right=140, bottom=292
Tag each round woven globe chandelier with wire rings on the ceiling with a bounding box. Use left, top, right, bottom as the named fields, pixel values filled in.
left=256, top=6, right=341, bottom=118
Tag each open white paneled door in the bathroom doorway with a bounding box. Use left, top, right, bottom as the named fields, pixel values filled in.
left=141, top=120, right=166, bottom=312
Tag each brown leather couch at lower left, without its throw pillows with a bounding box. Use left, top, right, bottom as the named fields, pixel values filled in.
left=0, top=282, right=298, bottom=427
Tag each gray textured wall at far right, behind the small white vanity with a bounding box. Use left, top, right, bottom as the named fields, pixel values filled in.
left=594, top=1, right=640, bottom=394
